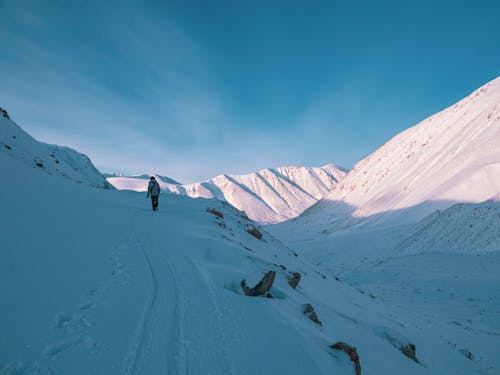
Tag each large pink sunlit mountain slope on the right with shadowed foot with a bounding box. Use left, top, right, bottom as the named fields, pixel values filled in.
left=288, top=78, right=500, bottom=230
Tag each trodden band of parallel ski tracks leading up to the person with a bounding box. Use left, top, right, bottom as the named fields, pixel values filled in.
left=123, top=212, right=232, bottom=375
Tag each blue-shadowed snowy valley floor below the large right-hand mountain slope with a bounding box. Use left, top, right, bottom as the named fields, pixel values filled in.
left=266, top=196, right=500, bottom=374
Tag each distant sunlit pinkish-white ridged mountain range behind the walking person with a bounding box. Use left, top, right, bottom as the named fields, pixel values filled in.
left=108, top=164, right=347, bottom=223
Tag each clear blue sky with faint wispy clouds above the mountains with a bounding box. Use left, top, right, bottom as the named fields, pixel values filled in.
left=0, top=0, right=500, bottom=182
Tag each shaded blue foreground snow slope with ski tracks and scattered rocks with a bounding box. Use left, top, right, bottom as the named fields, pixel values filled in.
left=0, top=134, right=488, bottom=375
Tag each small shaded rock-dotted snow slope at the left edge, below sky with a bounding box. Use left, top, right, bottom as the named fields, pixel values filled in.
left=0, top=111, right=113, bottom=189
